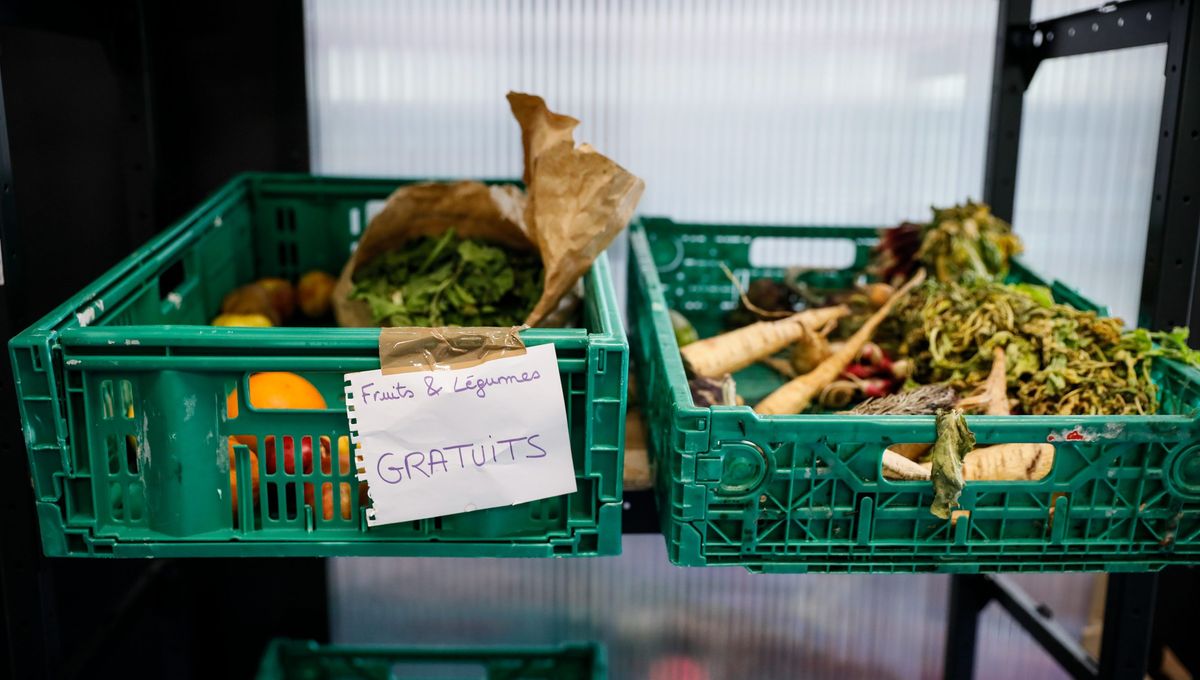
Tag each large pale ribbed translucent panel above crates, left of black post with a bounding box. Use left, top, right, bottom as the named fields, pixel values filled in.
left=306, top=0, right=996, bottom=305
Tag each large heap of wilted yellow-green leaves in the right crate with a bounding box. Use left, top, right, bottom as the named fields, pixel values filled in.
left=886, top=281, right=1161, bottom=415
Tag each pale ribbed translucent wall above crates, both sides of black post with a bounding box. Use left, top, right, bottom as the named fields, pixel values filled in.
left=307, top=0, right=1164, bottom=331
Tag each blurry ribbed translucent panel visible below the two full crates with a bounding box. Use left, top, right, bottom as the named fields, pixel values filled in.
left=329, top=535, right=1093, bottom=680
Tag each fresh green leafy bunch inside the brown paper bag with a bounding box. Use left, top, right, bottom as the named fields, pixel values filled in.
left=350, top=229, right=542, bottom=326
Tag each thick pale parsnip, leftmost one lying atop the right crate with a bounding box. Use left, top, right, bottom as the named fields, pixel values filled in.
left=679, top=306, right=850, bottom=377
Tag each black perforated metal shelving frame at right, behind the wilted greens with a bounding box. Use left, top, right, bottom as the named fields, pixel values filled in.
left=944, top=0, right=1200, bottom=680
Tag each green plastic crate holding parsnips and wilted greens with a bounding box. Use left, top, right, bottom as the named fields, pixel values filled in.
left=629, top=218, right=1200, bottom=572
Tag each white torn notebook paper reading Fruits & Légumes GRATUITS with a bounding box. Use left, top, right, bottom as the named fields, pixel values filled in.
left=346, top=344, right=575, bottom=526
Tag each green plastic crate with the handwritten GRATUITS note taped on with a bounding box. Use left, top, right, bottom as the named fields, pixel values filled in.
left=10, top=174, right=628, bottom=556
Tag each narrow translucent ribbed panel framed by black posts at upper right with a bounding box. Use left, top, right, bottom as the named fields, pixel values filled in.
left=1013, top=46, right=1166, bottom=325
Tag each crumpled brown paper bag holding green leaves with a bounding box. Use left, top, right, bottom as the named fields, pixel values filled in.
left=332, top=92, right=646, bottom=326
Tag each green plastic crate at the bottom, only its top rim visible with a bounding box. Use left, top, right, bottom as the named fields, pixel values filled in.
left=258, top=639, right=608, bottom=680
